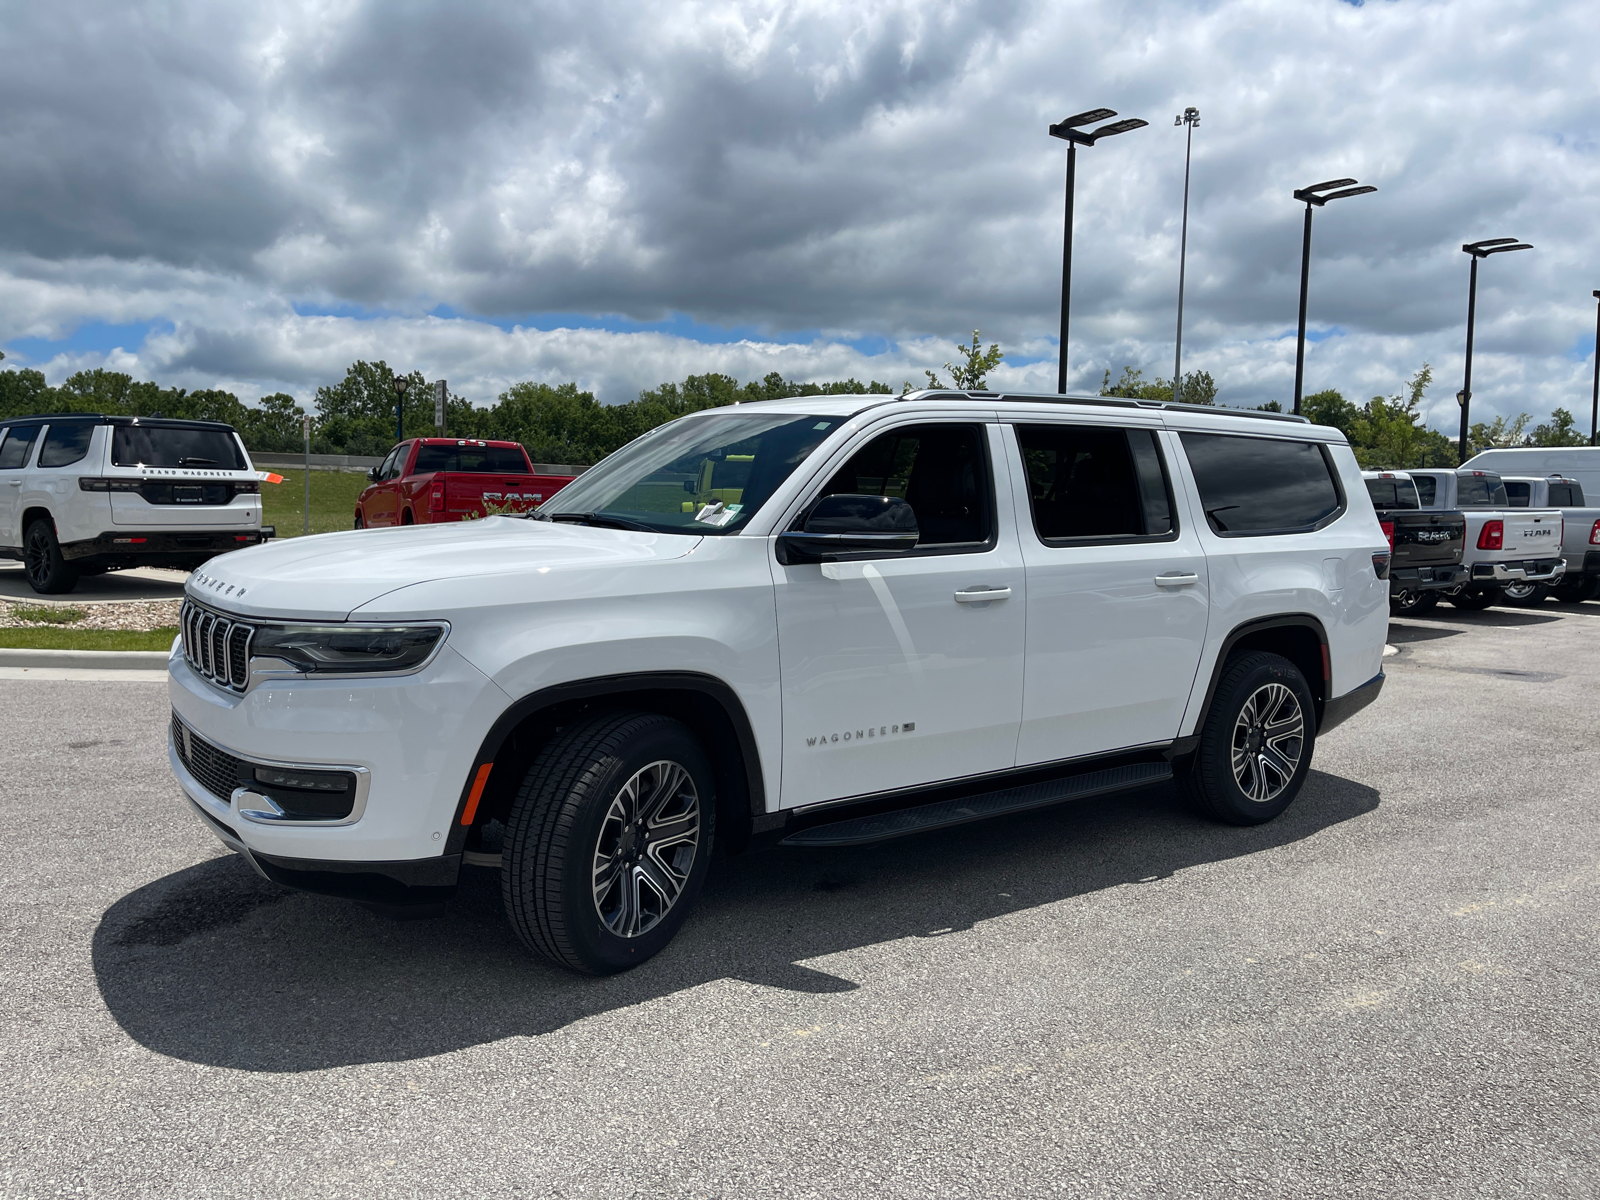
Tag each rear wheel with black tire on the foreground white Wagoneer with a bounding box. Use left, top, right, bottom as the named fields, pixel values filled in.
left=1178, top=650, right=1317, bottom=826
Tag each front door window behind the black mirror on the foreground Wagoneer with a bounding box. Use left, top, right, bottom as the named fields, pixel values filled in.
left=818, top=426, right=994, bottom=547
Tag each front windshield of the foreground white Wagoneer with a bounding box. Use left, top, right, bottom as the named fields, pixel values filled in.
left=539, top=411, right=843, bottom=534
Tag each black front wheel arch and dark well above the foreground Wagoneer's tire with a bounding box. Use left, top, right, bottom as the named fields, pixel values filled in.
left=445, top=670, right=766, bottom=854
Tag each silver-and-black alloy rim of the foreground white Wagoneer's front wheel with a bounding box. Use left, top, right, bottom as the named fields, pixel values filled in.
left=594, top=760, right=701, bottom=938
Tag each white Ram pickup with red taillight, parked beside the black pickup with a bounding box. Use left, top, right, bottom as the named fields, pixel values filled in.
left=1408, top=469, right=1566, bottom=611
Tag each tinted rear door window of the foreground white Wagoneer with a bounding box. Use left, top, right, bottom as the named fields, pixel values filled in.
left=1016, top=426, right=1174, bottom=542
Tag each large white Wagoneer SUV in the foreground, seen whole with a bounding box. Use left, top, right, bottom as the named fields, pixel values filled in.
left=170, top=392, right=1389, bottom=973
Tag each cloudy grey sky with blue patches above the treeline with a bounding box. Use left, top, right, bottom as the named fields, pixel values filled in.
left=0, top=0, right=1600, bottom=429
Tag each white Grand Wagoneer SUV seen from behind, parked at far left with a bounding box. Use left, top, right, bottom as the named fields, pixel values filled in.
left=0, top=413, right=272, bottom=594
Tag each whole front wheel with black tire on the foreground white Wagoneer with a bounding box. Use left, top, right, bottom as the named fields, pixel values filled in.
left=501, top=712, right=717, bottom=974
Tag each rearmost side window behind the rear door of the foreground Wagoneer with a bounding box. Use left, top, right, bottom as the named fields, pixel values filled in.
left=1182, top=434, right=1344, bottom=536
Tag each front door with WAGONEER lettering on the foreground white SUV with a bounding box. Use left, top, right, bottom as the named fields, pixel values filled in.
left=774, top=421, right=1026, bottom=808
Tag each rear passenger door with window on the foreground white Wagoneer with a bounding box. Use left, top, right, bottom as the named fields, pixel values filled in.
left=1006, top=421, right=1208, bottom=766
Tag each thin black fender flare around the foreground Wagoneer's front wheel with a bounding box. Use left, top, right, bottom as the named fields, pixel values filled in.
left=445, top=670, right=766, bottom=854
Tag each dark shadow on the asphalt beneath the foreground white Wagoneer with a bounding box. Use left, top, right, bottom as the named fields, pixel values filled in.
left=93, top=771, right=1379, bottom=1072
